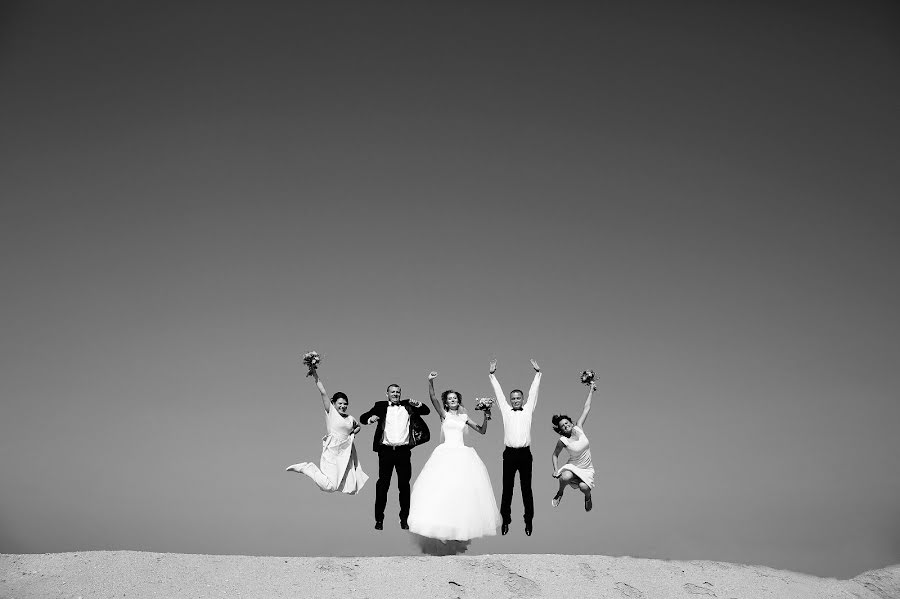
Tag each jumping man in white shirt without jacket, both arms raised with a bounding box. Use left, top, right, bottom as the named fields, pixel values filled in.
left=490, top=360, right=541, bottom=536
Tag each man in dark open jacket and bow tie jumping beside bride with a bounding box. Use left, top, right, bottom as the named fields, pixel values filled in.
left=359, top=384, right=431, bottom=530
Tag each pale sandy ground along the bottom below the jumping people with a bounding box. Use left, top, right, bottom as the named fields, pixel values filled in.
left=0, top=551, right=900, bottom=599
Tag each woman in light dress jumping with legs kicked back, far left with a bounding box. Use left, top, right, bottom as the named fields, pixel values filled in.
left=286, top=368, right=369, bottom=495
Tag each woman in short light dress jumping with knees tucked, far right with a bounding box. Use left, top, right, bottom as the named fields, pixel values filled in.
left=551, top=381, right=597, bottom=512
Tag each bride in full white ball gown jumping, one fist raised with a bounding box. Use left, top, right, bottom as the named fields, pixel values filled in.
left=408, top=372, right=501, bottom=541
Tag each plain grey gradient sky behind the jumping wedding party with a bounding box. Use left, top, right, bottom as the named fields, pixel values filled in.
left=0, top=1, right=900, bottom=577
